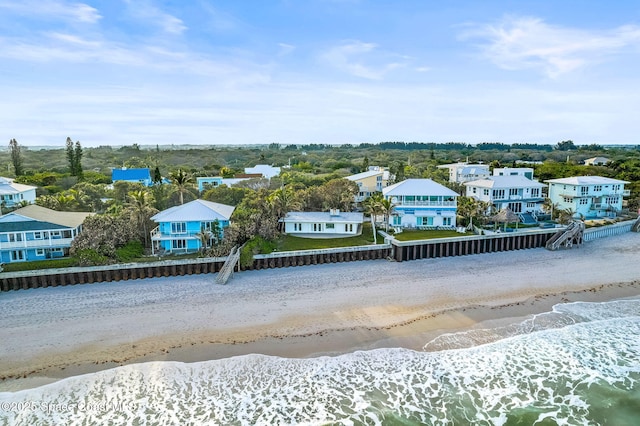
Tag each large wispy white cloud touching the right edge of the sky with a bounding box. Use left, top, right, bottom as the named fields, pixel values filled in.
left=461, top=17, right=640, bottom=78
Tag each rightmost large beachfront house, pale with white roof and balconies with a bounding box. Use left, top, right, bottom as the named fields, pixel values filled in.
left=545, top=176, right=629, bottom=219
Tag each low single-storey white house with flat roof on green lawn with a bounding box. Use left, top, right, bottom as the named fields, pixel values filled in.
left=281, top=209, right=364, bottom=238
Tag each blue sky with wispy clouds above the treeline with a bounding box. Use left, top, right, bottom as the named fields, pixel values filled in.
left=0, top=0, right=640, bottom=146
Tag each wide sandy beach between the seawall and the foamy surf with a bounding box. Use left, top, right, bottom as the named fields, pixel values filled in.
left=0, top=233, right=640, bottom=391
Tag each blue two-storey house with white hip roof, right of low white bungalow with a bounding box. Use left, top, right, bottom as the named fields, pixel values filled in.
left=382, top=179, right=459, bottom=229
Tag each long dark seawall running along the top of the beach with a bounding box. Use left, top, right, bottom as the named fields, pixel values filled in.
left=0, top=223, right=631, bottom=291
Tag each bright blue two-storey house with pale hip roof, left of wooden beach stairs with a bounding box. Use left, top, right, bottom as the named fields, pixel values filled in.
left=151, top=200, right=235, bottom=254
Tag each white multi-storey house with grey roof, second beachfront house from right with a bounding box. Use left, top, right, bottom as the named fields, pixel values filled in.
left=464, top=174, right=546, bottom=223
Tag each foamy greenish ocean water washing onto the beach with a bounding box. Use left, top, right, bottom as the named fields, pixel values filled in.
left=0, top=299, right=640, bottom=425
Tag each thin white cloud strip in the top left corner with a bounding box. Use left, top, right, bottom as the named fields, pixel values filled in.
left=0, top=0, right=102, bottom=24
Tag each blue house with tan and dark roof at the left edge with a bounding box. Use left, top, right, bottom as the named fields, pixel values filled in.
left=0, top=204, right=93, bottom=263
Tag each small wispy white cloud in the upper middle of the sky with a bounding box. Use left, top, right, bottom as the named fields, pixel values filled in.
left=321, top=40, right=405, bottom=80
